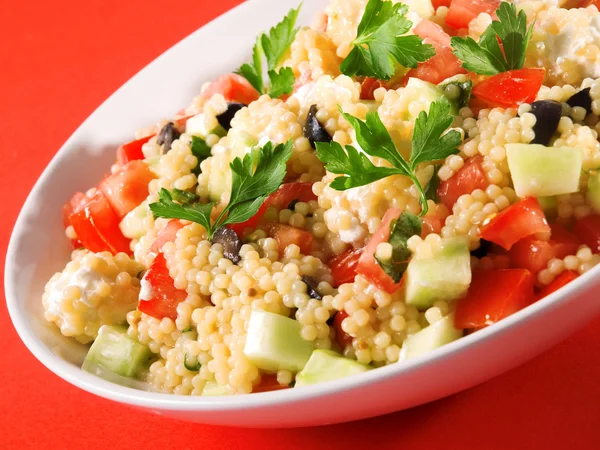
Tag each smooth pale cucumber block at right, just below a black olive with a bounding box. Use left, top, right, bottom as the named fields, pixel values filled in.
left=506, top=144, right=583, bottom=198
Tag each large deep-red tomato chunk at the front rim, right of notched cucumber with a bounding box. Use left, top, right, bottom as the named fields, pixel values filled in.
left=454, top=269, right=535, bottom=329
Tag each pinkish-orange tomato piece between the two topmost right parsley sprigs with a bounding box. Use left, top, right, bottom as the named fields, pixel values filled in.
left=405, top=19, right=467, bottom=84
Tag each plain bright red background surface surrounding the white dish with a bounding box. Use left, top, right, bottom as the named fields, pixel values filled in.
left=0, top=0, right=600, bottom=450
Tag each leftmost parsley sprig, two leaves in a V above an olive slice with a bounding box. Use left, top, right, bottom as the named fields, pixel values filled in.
left=149, top=141, right=292, bottom=239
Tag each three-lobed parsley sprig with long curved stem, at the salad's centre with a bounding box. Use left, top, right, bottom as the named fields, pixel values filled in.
left=316, top=98, right=462, bottom=215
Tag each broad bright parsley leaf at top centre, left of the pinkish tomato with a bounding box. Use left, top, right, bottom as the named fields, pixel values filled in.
left=340, top=0, right=435, bottom=80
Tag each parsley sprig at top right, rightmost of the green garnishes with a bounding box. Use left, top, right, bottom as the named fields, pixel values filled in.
left=452, top=2, right=533, bottom=75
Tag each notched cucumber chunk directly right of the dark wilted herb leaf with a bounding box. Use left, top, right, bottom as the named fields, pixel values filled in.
left=404, top=238, right=471, bottom=310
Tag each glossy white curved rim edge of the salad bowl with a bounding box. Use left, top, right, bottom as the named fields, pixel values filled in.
left=4, top=0, right=600, bottom=412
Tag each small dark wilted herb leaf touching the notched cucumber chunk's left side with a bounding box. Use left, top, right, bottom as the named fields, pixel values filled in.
left=375, top=211, right=421, bottom=283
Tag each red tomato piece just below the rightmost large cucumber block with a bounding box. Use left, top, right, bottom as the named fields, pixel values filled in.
left=480, top=197, right=550, bottom=250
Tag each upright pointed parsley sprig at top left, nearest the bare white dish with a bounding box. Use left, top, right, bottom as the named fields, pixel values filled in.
left=236, top=5, right=302, bottom=98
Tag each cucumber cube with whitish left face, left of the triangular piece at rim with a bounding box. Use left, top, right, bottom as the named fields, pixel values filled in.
left=244, top=310, right=314, bottom=372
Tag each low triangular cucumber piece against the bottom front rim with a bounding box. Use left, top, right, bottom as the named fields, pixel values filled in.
left=296, top=350, right=369, bottom=386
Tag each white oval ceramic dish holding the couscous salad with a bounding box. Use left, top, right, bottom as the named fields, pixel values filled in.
left=5, top=0, right=600, bottom=427
